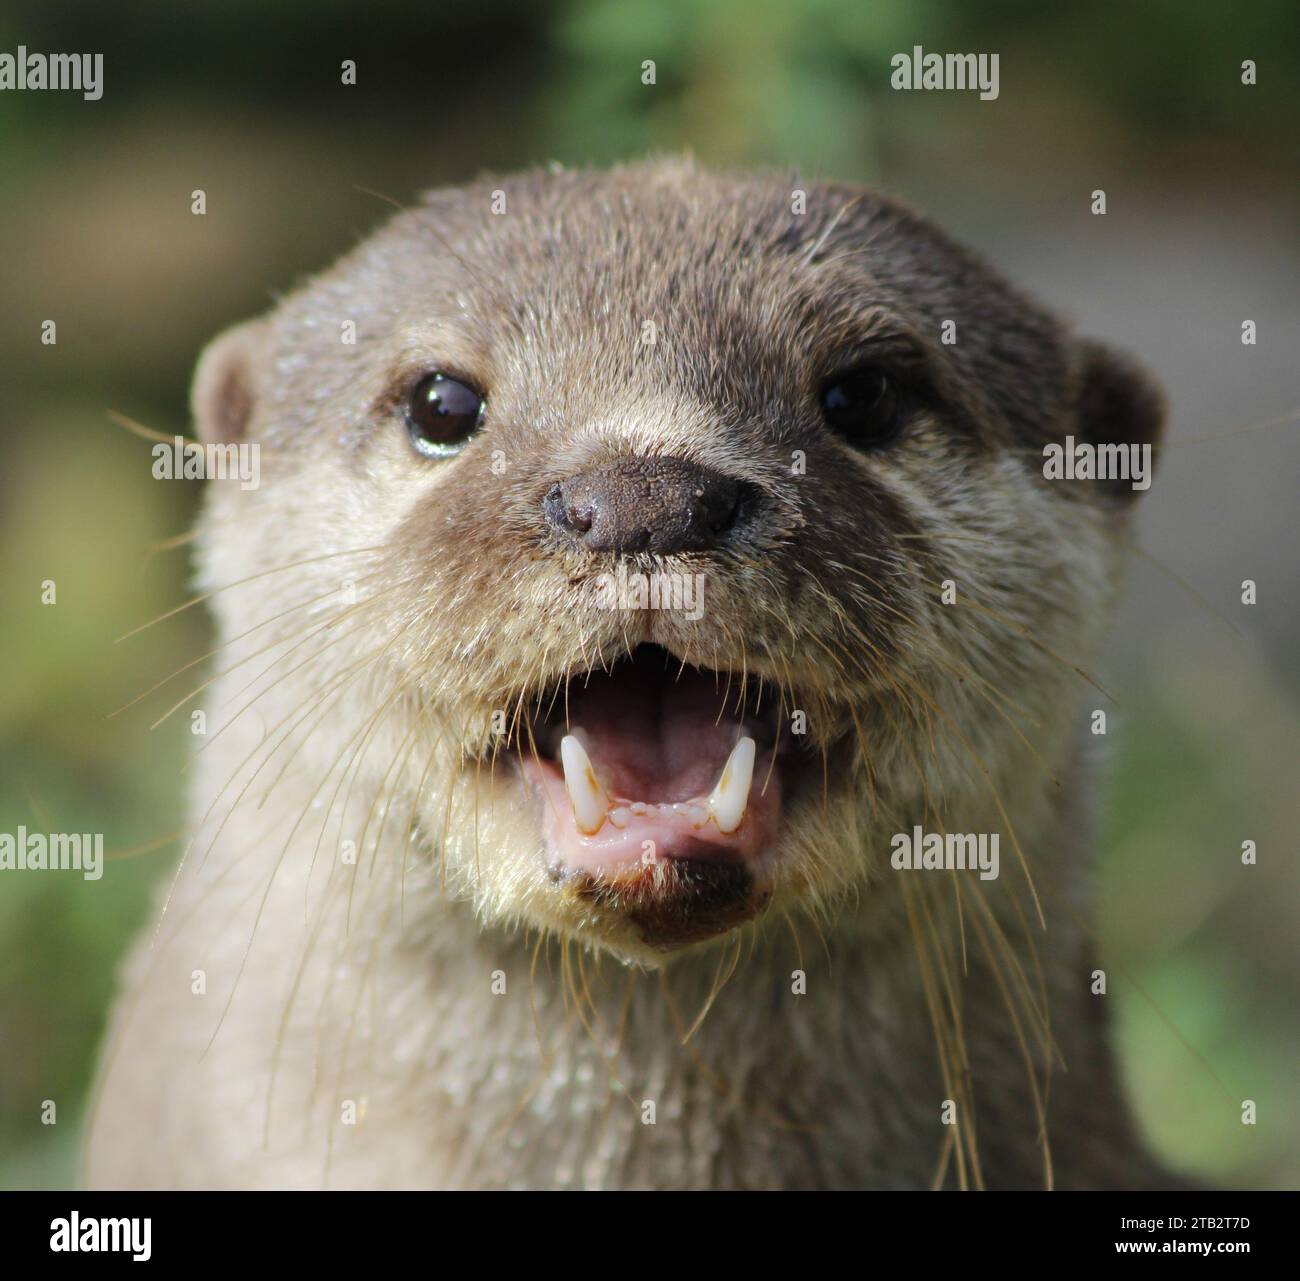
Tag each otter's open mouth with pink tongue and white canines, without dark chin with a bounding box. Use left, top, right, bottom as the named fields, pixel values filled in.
left=520, top=645, right=793, bottom=880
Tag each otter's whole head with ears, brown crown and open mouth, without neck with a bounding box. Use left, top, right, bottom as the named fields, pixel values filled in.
left=195, top=164, right=1160, bottom=964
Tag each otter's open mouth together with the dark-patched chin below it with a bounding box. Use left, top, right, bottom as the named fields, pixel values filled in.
left=519, top=646, right=793, bottom=952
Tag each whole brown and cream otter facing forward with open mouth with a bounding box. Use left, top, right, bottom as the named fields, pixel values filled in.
left=86, top=159, right=1173, bottom=1189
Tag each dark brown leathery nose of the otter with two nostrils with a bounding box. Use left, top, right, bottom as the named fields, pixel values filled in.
left=543, top=458, right=749, bottom=555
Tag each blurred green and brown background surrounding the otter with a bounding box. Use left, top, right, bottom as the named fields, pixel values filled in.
left=0, top=0, right=1300, bottom=1187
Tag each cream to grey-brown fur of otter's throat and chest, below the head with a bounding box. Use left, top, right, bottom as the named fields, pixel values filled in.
left=88, top=655, right=1153, bottom=1189
